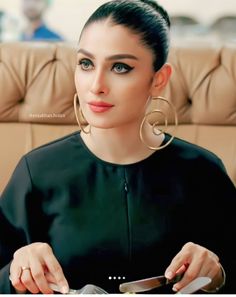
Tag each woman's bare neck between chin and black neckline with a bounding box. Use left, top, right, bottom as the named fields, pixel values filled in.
left=81, top=120, right=164, bottom=164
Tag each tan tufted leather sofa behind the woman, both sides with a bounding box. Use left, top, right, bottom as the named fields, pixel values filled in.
left=0, top=43, right=236, bottom=193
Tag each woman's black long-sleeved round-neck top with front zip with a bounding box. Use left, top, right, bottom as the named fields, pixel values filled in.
left=0, top=132, right=236, bottom=293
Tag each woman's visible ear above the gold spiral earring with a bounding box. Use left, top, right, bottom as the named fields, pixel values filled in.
left=151, top=63, right=172, bottom=96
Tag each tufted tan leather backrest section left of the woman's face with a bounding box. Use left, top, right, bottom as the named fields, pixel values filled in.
left=0, top=43, right=75, bottom=124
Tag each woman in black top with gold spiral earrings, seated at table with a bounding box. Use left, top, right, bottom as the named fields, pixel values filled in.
left=0, top=0, right=236, bottom=294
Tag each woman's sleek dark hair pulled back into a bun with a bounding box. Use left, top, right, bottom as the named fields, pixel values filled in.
left=81, top=0, right=170, bottom=71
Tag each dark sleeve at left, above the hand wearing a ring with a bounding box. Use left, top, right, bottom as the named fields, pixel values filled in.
left=0, top=158, right=31, bottom=293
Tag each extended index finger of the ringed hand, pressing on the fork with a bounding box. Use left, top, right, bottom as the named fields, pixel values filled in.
left=45, top=254, right=69, bottom=294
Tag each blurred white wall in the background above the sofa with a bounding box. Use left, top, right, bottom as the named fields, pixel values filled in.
left=0, top=0, right=236, bottom=41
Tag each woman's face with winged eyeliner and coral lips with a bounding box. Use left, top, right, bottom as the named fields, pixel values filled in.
left=75, top=20, right=158, bottom=128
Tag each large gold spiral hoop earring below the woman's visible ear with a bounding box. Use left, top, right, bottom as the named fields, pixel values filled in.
left=139, top=96, right=178, bottom=151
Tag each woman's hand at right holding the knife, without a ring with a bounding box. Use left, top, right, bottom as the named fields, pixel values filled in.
left=165, top=242, right=224, bottom=291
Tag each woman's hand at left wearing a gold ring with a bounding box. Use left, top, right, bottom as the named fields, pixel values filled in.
left=10, top=242, right=69, bottom=294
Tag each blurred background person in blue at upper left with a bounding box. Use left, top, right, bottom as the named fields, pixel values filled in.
left=20, top=0, right=63, bottom=41
